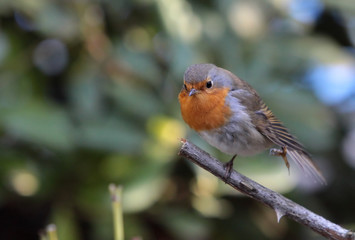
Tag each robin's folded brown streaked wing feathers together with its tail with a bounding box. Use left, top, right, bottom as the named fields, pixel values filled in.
left=255, top=102, right=326, bottom=184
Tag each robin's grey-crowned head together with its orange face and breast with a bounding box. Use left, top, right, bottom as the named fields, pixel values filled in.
left=179, top=64, right=233, bottom=131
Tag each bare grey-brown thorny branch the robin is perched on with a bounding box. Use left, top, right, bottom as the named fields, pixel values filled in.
left=179, top=139, right=355, bottom=240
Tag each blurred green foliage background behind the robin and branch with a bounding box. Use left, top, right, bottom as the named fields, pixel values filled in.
left=0, top=0, right=355, bottom=240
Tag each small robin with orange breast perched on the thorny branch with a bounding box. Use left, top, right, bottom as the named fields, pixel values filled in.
left=178, top=63, right=326, bottom=184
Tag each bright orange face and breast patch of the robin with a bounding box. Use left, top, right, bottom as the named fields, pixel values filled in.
left=179, top=88, right=231, bottom=131
